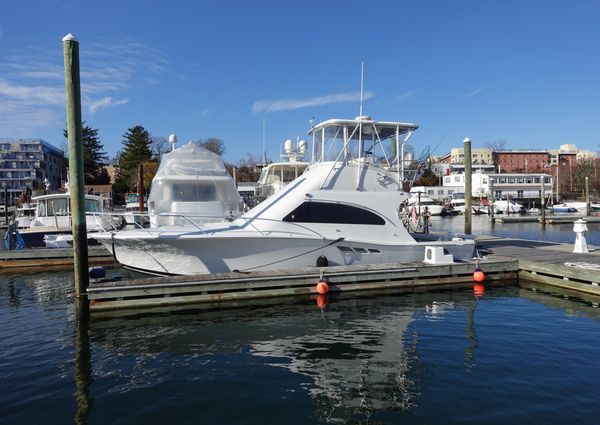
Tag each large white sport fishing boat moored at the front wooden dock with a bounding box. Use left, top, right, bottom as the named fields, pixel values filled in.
left=97, top=116, right=475, bottom=274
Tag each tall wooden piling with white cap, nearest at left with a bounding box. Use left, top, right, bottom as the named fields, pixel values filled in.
left=62, top=34, right=89, bottom=309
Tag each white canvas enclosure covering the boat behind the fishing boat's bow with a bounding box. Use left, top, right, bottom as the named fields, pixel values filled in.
left=148, top=142, right=243, bottom=226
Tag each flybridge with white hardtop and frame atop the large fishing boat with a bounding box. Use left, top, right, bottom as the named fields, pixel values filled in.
left=308, top=115, right=419, bottom=186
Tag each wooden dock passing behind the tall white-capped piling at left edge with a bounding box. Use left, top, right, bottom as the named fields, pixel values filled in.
left=0, top=246, right=116, bottom=273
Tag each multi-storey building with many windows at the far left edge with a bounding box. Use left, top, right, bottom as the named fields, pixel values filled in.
left=0, top=139, right=66, bottom=202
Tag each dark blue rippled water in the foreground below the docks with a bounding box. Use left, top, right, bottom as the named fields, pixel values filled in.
left=0, top=264, right=600, bottom=424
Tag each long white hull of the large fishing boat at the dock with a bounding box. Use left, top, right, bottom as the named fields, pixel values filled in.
left=99, top=229, right=475, bottom=275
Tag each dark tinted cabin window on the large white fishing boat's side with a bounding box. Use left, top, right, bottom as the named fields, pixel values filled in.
left=283, top=201, right=385, bottom=225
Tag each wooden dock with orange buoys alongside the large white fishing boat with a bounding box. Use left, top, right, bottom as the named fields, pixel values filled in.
left=88, top=258, right=518, bottom=311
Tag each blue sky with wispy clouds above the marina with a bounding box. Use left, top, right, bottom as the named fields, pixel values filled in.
left=0, top=0, right=600, bottom=162
